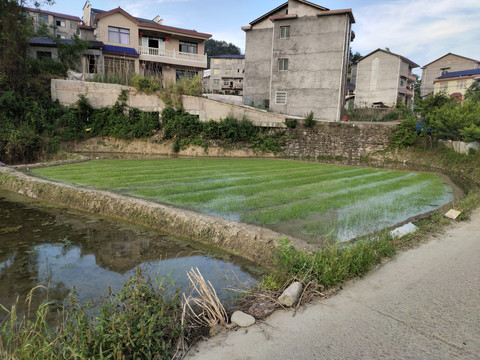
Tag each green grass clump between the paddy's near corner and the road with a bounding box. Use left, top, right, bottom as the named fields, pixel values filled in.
left=264, top=235, right=395, bottom=289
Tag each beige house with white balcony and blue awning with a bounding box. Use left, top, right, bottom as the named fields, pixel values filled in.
left=81, top=1, right=211, bottom=86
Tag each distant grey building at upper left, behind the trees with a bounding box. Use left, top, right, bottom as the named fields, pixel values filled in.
left=26, top=8, right=82, bottom=39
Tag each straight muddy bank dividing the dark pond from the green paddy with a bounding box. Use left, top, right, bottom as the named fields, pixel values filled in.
left=0, top=167, right=312, bottom=267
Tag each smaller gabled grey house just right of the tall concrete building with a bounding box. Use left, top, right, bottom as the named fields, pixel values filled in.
left=355, top=49, right=419, bottom=107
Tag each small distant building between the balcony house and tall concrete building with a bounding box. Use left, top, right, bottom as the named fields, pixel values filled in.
left=205, top=55, right=245, bottom=95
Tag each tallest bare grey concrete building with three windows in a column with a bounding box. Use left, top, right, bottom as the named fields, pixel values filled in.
left=242, top=0, right=355, bottom=121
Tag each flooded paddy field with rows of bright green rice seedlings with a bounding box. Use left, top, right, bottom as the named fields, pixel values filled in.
left=32, top=158, right=454, bottom=244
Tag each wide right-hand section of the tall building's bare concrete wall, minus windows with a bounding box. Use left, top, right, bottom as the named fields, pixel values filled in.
left=270, top=15, right=348, bottom=121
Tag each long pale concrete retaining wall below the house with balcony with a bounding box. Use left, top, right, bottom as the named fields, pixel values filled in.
left=51, top=79, right=286, bottom=128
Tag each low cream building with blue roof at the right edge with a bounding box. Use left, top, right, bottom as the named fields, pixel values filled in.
left=433, top=69, right=480, bottom=101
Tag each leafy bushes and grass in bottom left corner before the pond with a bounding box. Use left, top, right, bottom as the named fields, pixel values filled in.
left=0, top=270, right=184, bottom=360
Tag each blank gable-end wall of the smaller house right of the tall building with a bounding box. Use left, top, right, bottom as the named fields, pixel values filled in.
left=355, top=51, right=402, bottom=108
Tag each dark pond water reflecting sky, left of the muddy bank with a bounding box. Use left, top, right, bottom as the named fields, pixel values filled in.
left=0, top=190, right=258, bottom=321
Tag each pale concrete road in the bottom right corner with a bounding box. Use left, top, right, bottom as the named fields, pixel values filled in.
left=187, top=211, right=480, bottom=360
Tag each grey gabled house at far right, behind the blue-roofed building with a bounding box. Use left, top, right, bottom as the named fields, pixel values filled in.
left=420, top=53, right=480, bottom=98
